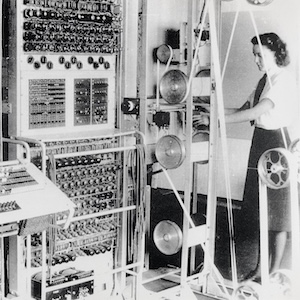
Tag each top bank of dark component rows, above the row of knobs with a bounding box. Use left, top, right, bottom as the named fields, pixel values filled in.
left=22, top=0, right=121, bottom=53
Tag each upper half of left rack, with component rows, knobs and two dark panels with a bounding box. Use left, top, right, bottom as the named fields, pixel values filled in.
left=4, top=0, right=123, bottom=137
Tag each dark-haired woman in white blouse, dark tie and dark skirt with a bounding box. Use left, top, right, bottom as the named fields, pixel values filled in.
left=194, top=33, right=297, bottom=280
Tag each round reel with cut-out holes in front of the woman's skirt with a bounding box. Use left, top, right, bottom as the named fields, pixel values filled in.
left=258, top=148, right=293, bottom=189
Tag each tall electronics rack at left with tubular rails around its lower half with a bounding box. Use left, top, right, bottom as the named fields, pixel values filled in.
left=1, top=0, right=144, bottom=300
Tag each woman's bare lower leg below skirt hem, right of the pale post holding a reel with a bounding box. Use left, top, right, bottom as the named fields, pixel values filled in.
left=270, top=231, right=287, bottom=274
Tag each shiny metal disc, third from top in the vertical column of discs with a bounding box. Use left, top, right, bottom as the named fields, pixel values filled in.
left=155, top=135, right=185, bottom=169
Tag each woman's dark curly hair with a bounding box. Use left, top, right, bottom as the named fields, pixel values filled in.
left=251, top=32, right=290, bottom=67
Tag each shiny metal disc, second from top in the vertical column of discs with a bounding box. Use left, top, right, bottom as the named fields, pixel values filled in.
left=159, top=70, right=188, bottom=104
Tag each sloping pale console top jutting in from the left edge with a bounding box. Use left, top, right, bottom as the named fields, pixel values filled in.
left=0, top=161, right=74, bottom=225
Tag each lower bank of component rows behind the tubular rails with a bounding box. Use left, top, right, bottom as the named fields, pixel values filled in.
left=32, top=146, right=123, bottom=267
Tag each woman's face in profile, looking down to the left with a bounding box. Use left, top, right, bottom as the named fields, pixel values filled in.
left=253, top=45, right=276, bottom=72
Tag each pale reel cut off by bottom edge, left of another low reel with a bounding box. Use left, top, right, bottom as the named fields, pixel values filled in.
left=232, top=281, right=262, bottom=300
